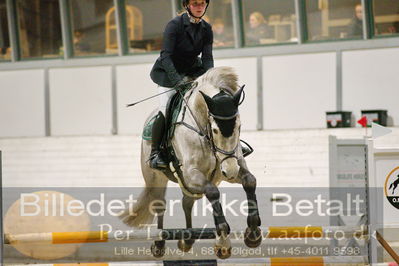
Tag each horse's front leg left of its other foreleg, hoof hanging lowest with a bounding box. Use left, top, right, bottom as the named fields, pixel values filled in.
left=186, top=169, right=231, bottom=259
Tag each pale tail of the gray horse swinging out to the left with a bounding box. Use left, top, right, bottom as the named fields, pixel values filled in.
left=119, top=186, right=166, bottom=227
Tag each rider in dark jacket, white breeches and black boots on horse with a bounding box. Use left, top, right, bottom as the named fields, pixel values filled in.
left=150, top=0, right=213, bottom=169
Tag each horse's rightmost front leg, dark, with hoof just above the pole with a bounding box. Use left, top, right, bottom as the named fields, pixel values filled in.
left=239, top=163, right=262, bottom=248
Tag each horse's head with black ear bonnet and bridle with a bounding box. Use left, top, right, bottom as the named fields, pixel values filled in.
left=201, top=86, right=244, bottom=179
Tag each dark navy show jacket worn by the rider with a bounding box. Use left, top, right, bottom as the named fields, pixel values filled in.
left=150, top=13, right=213, bottom=88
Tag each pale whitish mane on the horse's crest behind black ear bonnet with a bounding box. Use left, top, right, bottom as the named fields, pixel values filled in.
left=197, top=66, right=238, bottom=97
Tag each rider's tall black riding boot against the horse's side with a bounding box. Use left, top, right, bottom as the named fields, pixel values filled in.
left=150, top=112, right=167, bottom=170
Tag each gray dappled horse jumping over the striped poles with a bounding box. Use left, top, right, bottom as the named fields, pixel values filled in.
left=121, top=67, right=262, bottom=258
